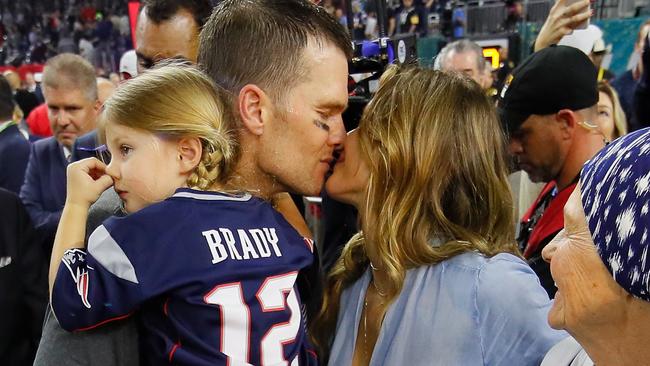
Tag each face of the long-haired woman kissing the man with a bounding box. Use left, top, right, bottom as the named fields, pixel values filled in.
left=325, top=129, right=370, bottom=208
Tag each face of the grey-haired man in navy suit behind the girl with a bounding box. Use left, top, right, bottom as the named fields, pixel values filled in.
left=43, top=85, right=98, bottom=147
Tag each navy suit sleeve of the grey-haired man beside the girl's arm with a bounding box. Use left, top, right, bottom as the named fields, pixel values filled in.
left=20, top=144, right=63, bottom=232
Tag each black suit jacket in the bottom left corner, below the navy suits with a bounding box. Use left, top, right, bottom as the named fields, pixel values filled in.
left=0, top=188, right=49, bottom=366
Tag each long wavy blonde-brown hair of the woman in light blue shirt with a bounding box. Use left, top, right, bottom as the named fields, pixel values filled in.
left=312, top=67, right=518, bottom=357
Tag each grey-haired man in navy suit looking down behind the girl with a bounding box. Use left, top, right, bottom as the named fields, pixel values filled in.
left=20, top=53, right=99, bottom=249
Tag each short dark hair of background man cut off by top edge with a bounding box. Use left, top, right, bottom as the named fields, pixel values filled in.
left=141, top=0, right=212, bottom=29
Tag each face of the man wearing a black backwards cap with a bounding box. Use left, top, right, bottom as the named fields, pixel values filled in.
left=508, top=114, right=566, bottom=182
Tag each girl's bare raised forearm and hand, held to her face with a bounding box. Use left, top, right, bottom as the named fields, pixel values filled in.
left=49, top=158, right=113, bottom=297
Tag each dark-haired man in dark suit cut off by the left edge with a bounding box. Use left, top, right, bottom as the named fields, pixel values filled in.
left=0, top=76, right=29, bottom=194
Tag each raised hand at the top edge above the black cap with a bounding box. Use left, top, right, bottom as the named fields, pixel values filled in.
left=535, top=0, right=591, bottom=52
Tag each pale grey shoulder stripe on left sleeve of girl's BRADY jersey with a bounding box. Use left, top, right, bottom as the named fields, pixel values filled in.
left=88, top=225, right=138, bottom=283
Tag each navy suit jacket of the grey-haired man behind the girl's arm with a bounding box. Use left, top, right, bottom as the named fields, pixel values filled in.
left=20, top=137, right=68, bottom=241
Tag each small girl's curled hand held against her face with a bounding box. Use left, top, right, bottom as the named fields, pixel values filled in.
left=66, top=158, right=113, bottom=207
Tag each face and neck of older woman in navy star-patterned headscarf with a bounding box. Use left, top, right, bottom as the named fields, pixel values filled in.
left=542, top=185, right=626, bottom=335
